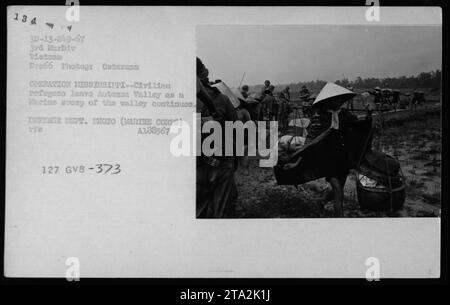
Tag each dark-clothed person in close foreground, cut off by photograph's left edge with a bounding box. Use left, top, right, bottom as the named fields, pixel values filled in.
left=196, top=58, right=238, bottom=218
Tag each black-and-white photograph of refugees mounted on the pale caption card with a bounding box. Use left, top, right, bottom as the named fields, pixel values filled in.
left=196, top=25, right=442, bottom=218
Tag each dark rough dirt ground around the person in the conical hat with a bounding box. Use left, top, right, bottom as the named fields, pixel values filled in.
left=235, top=104, right=441, bottom=218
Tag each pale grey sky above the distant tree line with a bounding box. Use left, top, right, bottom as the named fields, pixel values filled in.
left=196, top=25, right=442, bottom=87
